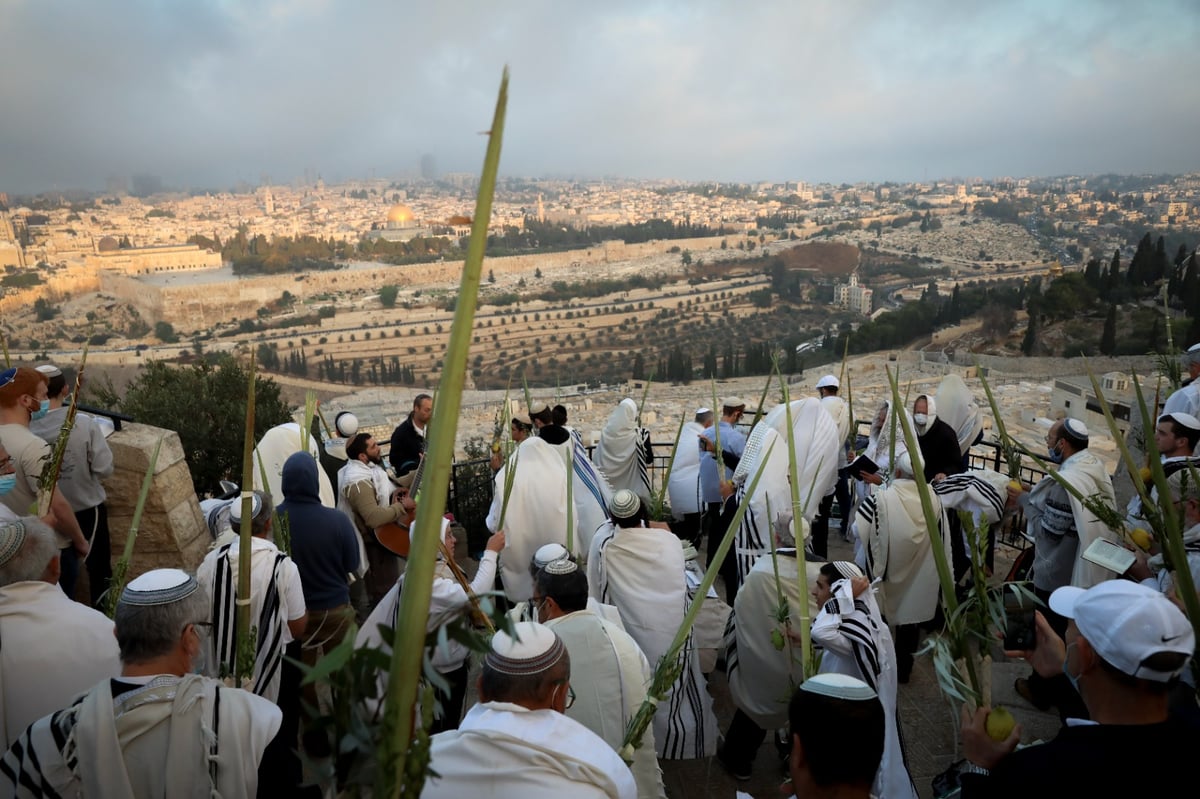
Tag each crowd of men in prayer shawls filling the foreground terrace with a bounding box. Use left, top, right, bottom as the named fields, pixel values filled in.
left=0, top=344, right=1200, bottom=799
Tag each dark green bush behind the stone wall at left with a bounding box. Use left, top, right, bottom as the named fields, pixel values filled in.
left=97, top=354, right=292, bottom=495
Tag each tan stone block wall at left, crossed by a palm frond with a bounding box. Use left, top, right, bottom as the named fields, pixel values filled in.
left=104, top=422, right=211, bottom=578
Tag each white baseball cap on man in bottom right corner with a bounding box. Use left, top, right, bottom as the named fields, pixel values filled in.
left=1050, top=579, right=1195, bottom=683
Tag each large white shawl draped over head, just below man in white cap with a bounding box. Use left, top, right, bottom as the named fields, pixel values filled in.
left=733, top=397, right=841, bottom=578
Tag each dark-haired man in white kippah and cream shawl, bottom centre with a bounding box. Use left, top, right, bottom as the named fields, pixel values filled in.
left=533, top=558, right=666, bottom=799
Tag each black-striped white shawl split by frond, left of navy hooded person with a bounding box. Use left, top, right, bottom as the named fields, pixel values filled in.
left=212, top=541, right=287, bottom=702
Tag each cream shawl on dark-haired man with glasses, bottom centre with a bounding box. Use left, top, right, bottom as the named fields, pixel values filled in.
left=545, top=611, right=666, bottom=799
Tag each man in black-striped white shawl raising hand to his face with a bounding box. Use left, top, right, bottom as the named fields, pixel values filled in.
left=812, top=560, right=917, bottom=799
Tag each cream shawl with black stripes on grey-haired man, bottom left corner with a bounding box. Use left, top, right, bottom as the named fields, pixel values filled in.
left=0, top=674, right=282, bottom=799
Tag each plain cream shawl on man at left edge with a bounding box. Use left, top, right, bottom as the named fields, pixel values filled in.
left=0, top=579, right=121, bottom=749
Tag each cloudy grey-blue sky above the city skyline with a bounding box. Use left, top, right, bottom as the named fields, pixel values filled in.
left=0, top=0, right=1200, bottom=193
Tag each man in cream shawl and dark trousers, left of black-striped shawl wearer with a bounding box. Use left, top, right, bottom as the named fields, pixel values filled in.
left=716, top=507, right=821, bottom=780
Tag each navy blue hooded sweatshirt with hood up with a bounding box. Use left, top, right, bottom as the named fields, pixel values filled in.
left=278, top=452, right=359, bottom=611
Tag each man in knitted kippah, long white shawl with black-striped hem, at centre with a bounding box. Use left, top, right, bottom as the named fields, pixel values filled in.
left=588, top=488, right=716, bottom=759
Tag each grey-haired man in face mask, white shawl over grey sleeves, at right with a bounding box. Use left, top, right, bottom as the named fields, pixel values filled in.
left=1009, top=417, right=1118, bottom=710
